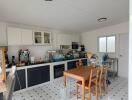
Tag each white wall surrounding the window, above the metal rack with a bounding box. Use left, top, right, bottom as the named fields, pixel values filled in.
left=81, top=22, right=129, bottom=77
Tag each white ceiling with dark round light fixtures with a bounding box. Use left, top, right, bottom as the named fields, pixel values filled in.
left=0, top=0, right=129, bottom=32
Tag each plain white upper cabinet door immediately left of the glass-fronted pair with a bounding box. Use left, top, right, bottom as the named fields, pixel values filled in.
left=21, top=29, right=33, bottom=45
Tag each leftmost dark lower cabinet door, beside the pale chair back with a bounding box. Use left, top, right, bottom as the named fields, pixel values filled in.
left=6, top=69, right=26, bottom=91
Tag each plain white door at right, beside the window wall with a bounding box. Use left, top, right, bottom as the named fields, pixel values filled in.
left=119, top=34, right=129, bottom=78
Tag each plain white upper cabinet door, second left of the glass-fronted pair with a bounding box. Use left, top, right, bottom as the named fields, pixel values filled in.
left=7, top=27, right=21, bottom=45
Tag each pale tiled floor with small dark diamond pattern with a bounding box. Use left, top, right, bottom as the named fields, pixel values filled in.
left=13, top=77, right=128, bottom=100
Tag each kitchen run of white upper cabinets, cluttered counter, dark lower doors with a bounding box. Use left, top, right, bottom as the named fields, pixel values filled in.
left=0, top=22, right=87, bottom=98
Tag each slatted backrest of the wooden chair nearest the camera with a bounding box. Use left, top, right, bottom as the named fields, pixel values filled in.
left=89, top=68, right=99, bottom=87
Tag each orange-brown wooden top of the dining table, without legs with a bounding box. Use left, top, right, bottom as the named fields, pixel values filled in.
left=64, top=67, right=92, bottom=80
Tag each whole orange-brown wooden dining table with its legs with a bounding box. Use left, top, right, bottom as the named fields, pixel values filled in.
left=64, top=66, right=93, bottom=100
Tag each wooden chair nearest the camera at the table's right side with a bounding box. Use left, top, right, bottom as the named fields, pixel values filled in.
left=76, top=68, right=99, bottom=100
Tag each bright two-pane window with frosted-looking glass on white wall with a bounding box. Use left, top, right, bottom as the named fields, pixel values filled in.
left=98, top=36, right=115, bottom=53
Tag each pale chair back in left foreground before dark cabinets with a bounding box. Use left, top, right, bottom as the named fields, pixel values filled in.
left=5, top=66, right=16, bottom=100
